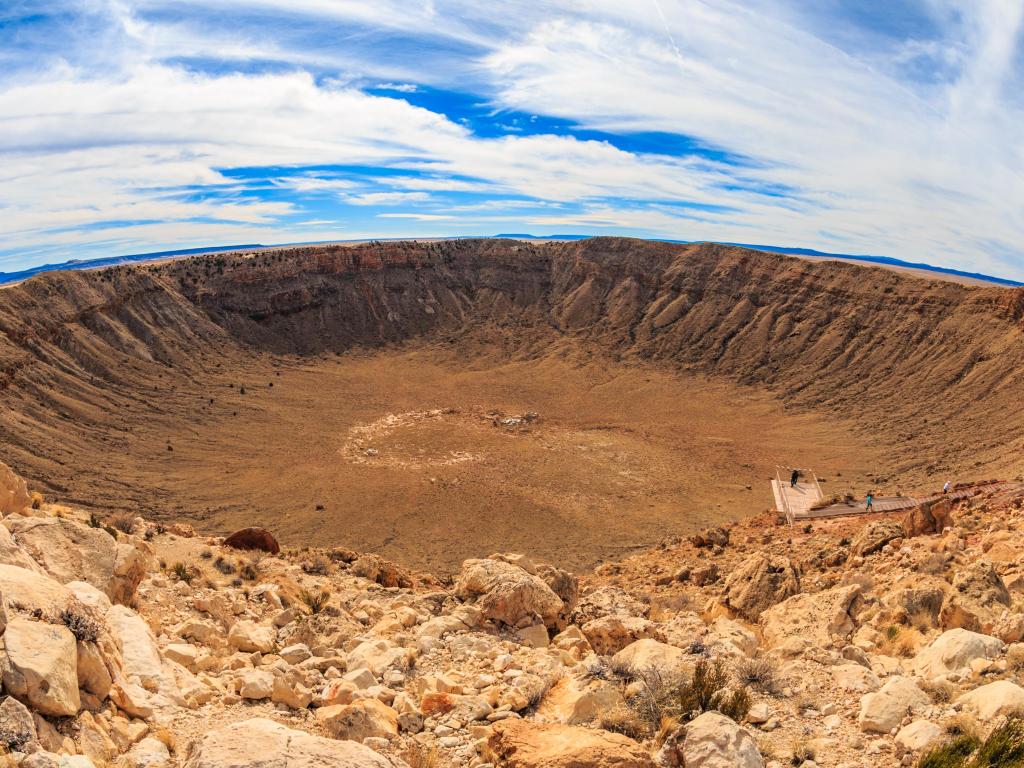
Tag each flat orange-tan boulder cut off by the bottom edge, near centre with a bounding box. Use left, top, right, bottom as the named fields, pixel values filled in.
left=484, top=719, right=654, bottom=768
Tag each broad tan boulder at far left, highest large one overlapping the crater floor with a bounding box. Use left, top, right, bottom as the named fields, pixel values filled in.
left=9, top=517, right=146, bottom=604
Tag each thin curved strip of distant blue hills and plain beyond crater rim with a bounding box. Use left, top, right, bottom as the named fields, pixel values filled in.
left=0, top=232, right=1024, bottom=288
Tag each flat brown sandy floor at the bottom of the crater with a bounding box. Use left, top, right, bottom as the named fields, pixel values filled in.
left=108, top=349, right=879, bottom=571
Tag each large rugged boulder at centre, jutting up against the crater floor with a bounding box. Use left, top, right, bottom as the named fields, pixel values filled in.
left=456, top=559, right=565, bottom=630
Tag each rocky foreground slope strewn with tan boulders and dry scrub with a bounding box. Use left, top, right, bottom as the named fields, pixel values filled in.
left=0, top=465, right=1024, bottom=768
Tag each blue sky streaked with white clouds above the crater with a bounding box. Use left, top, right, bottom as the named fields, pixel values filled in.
left=0, top=0, right=1024, bottom=279
